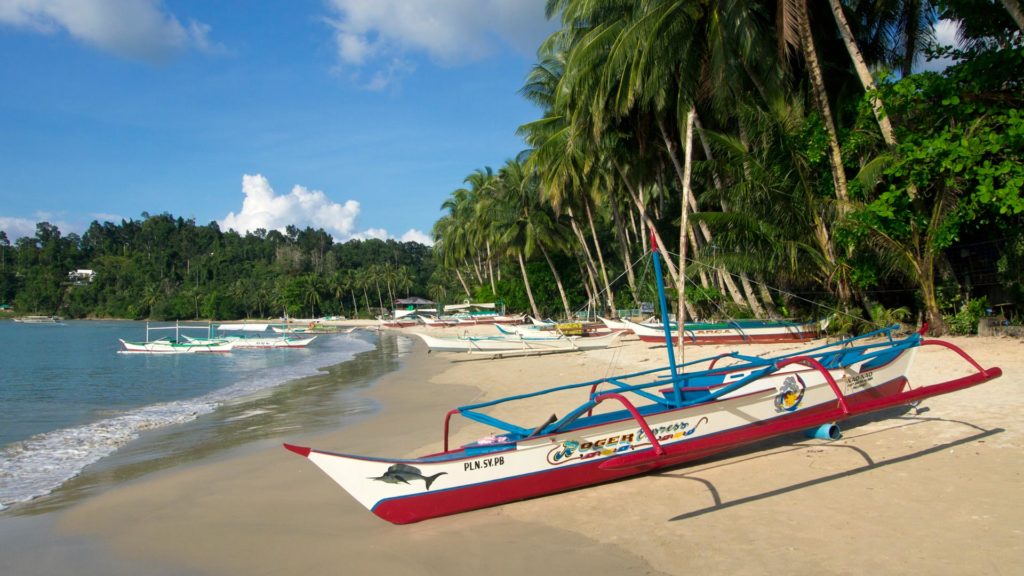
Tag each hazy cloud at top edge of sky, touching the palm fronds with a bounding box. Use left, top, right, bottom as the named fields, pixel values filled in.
left=326, top=0, right=555, bottom=89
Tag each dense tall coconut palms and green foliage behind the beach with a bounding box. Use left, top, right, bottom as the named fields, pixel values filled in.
left=433, top=0, right=1024, bottom=332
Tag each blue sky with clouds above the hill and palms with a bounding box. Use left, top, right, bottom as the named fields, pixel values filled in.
left=0, top=0, right=554, bottom=242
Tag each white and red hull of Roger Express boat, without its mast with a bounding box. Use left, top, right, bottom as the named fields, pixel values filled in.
left=286, top=334, right=1001, bottom=524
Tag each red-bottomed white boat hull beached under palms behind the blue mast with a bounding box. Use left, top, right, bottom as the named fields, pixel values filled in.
left=623, top=320, right=827, bottom=344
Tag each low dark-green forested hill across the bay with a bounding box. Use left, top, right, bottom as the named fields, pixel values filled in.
left=0, top=213, right=434, bottom=320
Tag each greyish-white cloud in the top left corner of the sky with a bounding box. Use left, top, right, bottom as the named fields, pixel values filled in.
left=0, top=0, right=219, bottom=63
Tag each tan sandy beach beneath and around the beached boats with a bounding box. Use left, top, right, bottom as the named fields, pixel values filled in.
left=0, top=327, right=1024, bottom=576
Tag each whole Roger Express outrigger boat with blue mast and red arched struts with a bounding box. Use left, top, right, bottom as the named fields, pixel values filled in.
left=285, top=243, right=1001, bottom=524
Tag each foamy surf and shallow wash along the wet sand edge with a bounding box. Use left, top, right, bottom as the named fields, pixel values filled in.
left=0, top=325, right=387, bottom=512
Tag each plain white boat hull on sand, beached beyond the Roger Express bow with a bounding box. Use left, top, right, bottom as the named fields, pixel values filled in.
left=416, top=332, right=618, bottom=354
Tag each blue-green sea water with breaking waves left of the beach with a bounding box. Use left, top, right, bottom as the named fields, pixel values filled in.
left=0, top=321, right=401, bottom=509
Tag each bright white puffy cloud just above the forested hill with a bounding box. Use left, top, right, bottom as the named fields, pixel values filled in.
left=219, top=174, right=359, bottom=238
